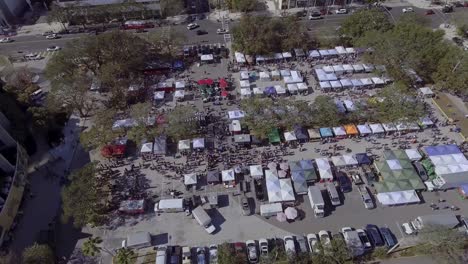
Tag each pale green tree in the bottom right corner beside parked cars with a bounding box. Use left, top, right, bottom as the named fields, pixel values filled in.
left=419, top=225, right=468, bottom=264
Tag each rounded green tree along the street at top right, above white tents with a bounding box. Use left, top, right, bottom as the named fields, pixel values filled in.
left=339, top=9, right=392, bottom=41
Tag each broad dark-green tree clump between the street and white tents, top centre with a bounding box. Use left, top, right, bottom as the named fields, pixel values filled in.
left=231, top=15, right=311, bottom=56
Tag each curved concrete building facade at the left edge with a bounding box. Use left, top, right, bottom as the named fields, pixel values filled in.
left=0, top=113, right=28, bottom=245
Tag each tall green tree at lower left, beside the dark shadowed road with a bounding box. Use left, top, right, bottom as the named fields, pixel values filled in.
left=61, top=163, right=106, bottom=227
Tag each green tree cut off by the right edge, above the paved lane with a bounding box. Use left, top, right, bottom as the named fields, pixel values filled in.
left=432, top=46, right=468, bottom=96
